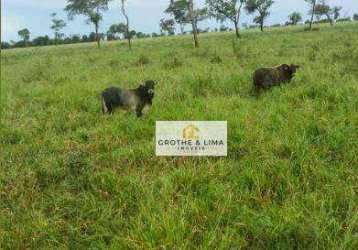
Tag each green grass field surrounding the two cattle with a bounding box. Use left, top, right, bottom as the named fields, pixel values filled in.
left=0, top=23, right=358, bottom=249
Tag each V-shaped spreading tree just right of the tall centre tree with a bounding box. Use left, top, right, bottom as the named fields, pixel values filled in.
left=206, top=0, right=246, bottom=38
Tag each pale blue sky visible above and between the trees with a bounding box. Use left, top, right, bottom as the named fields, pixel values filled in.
left=1, top=0, right=358, bottom=41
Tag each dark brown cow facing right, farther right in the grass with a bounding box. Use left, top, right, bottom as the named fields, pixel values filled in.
left=253, top=64, right=300, bottom=90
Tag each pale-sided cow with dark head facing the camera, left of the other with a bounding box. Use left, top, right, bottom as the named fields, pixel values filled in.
left=102, top=80, right=155, bottom=117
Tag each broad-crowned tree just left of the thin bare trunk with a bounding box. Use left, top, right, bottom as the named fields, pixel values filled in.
left=65, top=0, right=111, bottom=48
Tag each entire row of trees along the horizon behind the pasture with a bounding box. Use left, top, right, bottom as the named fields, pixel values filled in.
left=1, top=0, right=358, bottom=49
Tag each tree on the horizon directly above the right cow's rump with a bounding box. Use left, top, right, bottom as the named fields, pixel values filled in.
left=245, top=0, right=274, bottom=31
